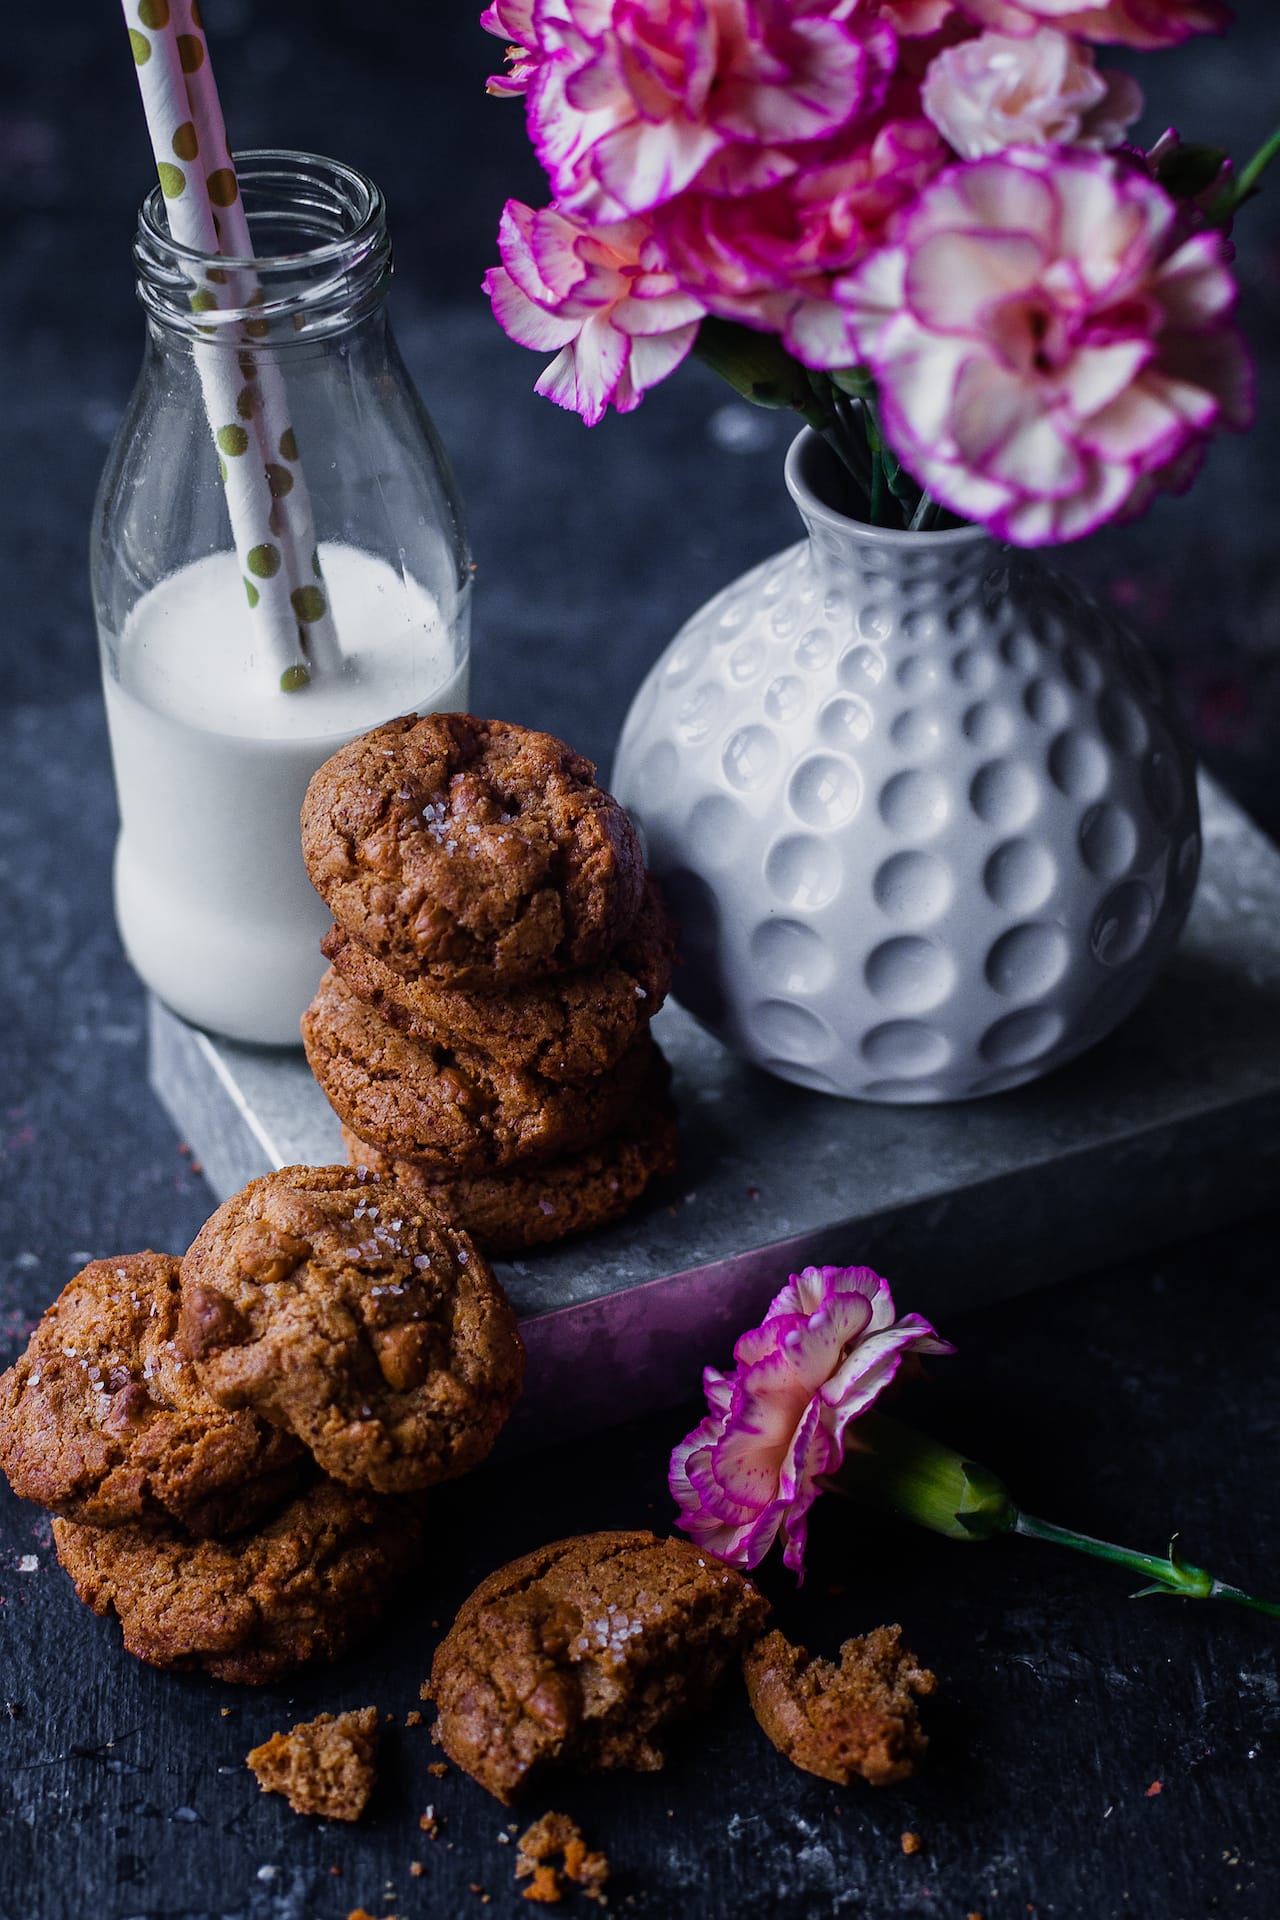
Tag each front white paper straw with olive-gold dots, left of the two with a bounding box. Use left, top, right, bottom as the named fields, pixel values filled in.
left=123, top=0, right=326, bottom=691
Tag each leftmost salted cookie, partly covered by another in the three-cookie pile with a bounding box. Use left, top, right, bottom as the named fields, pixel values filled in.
left=0, top=1254, right=305, bottom=1536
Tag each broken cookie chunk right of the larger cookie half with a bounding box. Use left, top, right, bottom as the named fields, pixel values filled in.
left=743, top=1626, right=936, bottom=1788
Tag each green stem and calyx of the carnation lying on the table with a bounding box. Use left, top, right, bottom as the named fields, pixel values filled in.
left=823, top=1413, right=1280, bottom=1619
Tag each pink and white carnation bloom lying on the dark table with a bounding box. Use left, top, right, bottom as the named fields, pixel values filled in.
left=670, top=1267, right=954, bottom=1576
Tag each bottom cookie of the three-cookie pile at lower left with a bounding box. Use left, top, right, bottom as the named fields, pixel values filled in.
left=54, top=1480, right=420, bottom=1686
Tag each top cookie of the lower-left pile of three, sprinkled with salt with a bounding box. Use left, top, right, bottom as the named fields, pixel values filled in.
left=178, top=1167, right=524, bottom=1494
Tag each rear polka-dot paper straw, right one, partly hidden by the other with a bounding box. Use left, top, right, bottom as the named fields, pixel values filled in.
left=169, top=0, right=340, bottom=666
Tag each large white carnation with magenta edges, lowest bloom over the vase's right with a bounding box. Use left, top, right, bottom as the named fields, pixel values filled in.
left=837, top=148, right=1251, bottom=547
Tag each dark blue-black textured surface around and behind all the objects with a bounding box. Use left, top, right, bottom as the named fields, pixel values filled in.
left=0, top=0, right=1280, bottom=1920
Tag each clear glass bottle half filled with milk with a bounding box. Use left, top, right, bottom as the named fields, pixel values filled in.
left=92, top=152, right=472, bottom=1046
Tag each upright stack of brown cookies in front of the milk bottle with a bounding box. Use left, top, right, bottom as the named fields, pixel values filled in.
left=301, top=714, right=676, bottom=1254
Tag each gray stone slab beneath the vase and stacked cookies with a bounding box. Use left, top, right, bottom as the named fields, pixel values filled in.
left=152, top=780, right=1280, bottom=1438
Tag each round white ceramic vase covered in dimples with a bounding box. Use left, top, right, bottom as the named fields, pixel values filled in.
left=612, top=434, right=1199, bottom=1102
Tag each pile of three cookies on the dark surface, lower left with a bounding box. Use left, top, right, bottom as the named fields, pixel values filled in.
left=0, top=1167, right=524, bottom=1682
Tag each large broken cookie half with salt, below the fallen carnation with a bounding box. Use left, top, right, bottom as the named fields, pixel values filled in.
left=422, top=1532, right=770, bottom=1803
